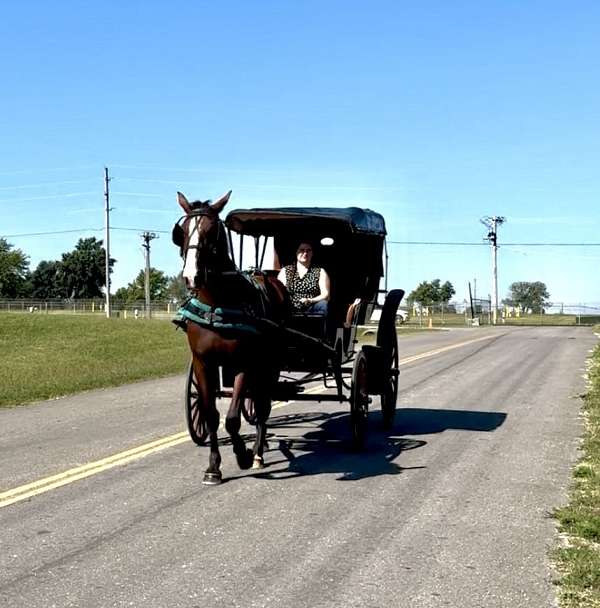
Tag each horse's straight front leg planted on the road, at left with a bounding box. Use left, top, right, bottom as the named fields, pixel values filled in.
left=194, top=356, right=223, bottom=485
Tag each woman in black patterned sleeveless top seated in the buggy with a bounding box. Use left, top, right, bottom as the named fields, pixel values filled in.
left=277, top=243, right=329, bottom=315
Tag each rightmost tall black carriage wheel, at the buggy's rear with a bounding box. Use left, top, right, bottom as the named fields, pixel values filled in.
left=377, top=289, right=404, bottom=429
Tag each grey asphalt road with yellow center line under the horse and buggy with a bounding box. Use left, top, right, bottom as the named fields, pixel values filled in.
left=0, top=327, right=597, bottom=608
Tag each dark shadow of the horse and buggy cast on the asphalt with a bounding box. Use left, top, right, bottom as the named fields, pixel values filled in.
left=223, top=408, right=506, bottom=481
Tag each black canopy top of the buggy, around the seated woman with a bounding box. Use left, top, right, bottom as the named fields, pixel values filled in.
left=225, top=207, right=386, bottom=324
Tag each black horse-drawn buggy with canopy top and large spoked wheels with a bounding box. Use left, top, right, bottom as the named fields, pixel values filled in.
left=185, top=207, right=404, bottom=448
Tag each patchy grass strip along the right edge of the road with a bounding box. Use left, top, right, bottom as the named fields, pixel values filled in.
left=553, top=326, right=600, bottom=608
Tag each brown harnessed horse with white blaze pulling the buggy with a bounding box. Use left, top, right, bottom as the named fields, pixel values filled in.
left=173, top=191, right=290, bottom=485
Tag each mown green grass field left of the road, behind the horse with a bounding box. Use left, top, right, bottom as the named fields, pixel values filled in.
left=0, top=313, right=189, bottom=407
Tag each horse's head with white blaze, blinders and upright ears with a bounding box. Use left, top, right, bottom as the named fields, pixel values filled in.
left=173, top=190, right=232, bottom=289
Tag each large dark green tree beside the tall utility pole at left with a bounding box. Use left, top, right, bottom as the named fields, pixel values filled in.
left=58, top=237, right=115, bottom=298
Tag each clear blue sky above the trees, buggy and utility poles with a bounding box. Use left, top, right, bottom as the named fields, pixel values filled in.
left=0, top=0, right=600, bottom=303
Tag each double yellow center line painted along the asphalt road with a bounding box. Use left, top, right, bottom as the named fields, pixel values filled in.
left=0, top=334, right=498, bottom=509
